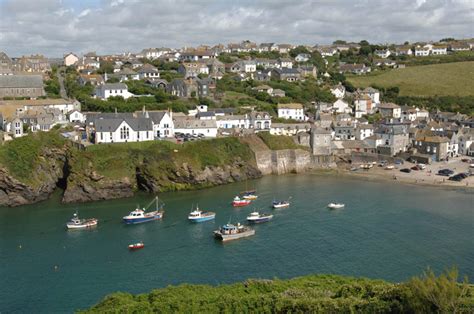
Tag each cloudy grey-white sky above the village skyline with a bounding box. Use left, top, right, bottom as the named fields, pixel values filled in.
left=0, top=0, right=474, bottom=57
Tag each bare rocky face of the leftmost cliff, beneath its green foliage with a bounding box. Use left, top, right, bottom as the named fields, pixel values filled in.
left=0, top=148, right=66, bottom=206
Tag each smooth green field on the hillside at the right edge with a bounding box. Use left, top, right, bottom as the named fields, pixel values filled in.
left=347, top=61, right=474, bottom=97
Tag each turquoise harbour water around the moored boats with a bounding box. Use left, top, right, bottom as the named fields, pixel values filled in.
left=0, top=175, right=474, bottom=313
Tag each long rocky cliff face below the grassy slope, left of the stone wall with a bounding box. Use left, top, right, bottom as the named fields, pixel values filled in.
left=63, top=157, right=262, bottom=203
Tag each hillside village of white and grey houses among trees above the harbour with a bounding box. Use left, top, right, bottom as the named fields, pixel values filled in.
left=0, top=39, right=474, bottom=168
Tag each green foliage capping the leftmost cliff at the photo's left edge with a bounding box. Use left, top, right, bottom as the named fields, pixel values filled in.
left=0, top=131, right=65, bottom=182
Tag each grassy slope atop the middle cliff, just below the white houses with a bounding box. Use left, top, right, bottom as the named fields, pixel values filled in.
left=74, top=138, right=253, bottom=179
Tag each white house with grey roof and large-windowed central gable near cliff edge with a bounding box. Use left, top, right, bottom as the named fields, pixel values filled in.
left=95, top=118, right=153, bottom=144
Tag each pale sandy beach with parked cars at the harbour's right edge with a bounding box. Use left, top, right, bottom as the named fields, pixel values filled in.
left=338, top=157, right=474, bottom=190
